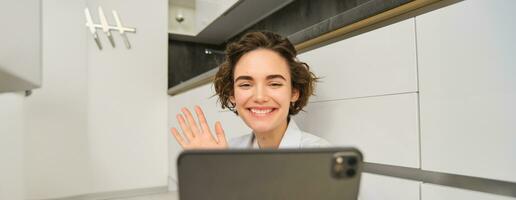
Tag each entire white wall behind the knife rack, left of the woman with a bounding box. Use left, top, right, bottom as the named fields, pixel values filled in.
left=24, top=0, right=168, bottom=199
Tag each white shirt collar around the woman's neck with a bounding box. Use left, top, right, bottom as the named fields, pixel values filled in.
left=249, top=119, right=301, bottom=149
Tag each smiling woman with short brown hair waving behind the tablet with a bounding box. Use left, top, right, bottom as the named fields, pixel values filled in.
left=172, top=32, right=329, bottom=149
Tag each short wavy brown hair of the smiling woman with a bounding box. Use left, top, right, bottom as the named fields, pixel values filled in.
left=214, top=31, right=318, bottom=116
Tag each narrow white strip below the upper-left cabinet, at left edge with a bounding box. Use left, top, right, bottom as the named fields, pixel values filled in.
left=0, top=93, right=25, bottom=200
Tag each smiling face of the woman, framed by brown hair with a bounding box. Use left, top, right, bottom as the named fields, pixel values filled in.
left=230, top=49, right=299, bottom=133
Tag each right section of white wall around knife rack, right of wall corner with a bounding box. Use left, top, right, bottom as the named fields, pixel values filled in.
left=84, top=0, right=168, bottom=192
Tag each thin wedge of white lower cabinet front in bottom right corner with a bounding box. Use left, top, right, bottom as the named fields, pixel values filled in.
left=421, top=183, right=516, bottom=200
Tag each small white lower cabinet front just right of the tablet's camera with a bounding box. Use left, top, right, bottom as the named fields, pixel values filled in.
left=358, top=173, right=420, bottom=200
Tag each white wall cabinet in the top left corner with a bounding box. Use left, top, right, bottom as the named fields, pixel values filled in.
left=0, top=0, right=42, bottom=92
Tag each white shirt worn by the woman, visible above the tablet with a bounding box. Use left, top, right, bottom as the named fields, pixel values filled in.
left=229, top=119, right=331, bottom=149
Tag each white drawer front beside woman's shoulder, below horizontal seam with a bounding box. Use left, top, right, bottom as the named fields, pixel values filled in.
left=294, top=93, right=419, bottom=168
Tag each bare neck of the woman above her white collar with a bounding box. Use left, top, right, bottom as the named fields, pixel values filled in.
left=254, top=121, right=288, bottom=149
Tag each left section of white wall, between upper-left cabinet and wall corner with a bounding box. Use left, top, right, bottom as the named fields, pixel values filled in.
left=25, top=0, right=92, bottom=198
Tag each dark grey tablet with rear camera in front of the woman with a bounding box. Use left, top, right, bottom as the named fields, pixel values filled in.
left=177, top=148, right=363, bottom=200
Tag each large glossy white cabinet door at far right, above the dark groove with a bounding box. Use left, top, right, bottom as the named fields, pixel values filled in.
left=416, top=0, right=516, bottom=182
